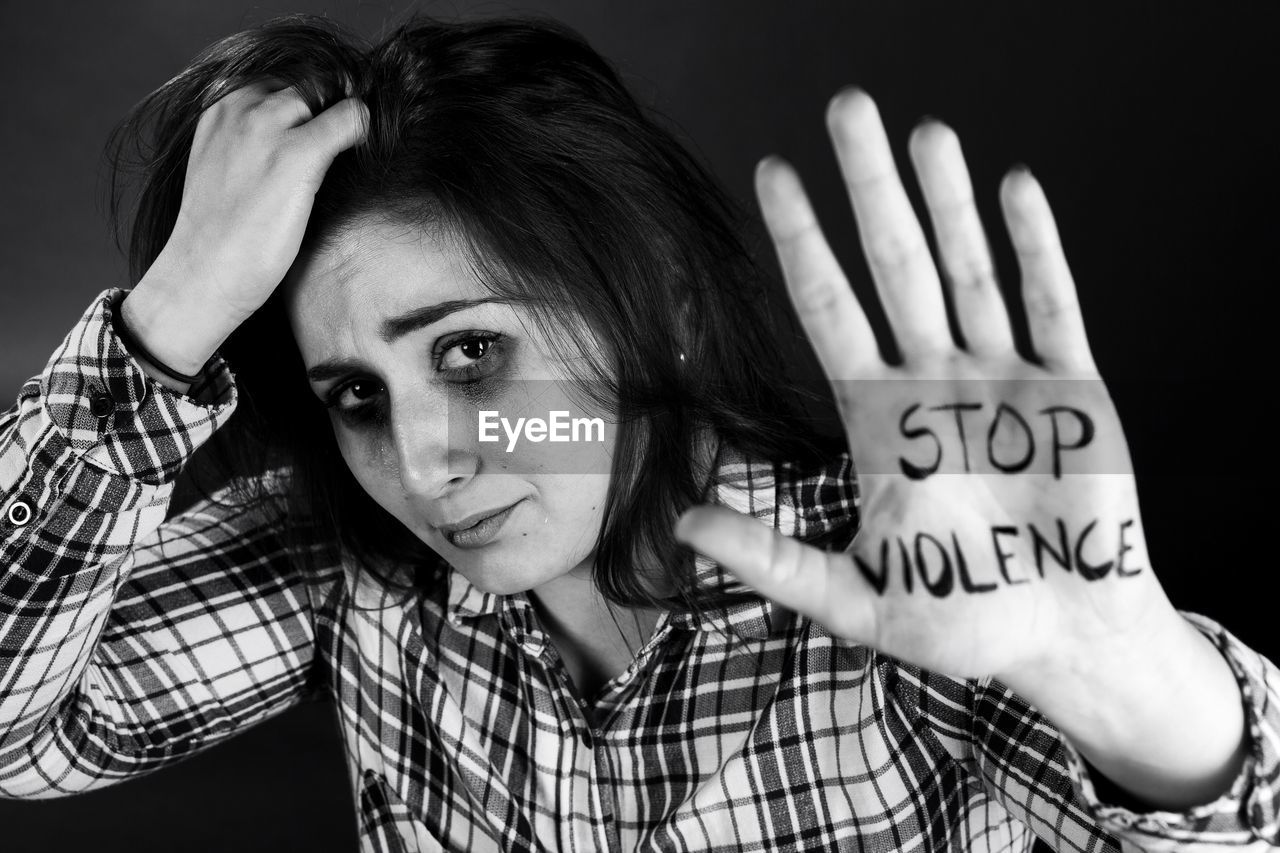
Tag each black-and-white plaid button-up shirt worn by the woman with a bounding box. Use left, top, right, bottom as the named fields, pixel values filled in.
left=0, top=288, right=1280, bottom=852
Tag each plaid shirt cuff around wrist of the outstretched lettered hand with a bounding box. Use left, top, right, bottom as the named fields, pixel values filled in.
left=1062, top=611, right=1280, bottom=849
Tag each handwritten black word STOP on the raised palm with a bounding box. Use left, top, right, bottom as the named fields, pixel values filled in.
left=899, top=402, right=1093, bottom=480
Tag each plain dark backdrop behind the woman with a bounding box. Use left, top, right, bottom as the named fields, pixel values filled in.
left=0, top=0, right=1280, bottom=853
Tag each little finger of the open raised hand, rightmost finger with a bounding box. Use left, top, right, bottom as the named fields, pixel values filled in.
left=1000, top=169, right=1093, bottom=373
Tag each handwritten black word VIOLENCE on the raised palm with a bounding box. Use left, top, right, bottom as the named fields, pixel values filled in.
left=852, top=519, right=1142, bottom=598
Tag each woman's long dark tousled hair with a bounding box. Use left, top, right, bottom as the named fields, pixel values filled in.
left=109, top=15, right=832, bottom=610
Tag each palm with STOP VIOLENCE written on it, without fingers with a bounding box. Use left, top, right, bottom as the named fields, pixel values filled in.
left=849, top=365, right=1153, bottom=678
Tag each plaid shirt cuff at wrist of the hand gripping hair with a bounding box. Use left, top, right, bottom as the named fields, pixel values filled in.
left=40, top=287, right=237, bottom=484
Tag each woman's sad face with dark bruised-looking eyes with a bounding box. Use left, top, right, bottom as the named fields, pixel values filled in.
left=283, top=222, right=616, bottom=593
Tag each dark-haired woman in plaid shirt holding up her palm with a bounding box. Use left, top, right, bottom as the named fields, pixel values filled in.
left=0, top=13, right=1280, bottom=850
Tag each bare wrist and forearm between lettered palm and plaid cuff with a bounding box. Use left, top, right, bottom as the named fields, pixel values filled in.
left=1010, top=607, right=1248, bottom=811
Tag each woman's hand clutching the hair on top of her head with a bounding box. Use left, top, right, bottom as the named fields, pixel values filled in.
left=124, top=79, right=369, bottom=381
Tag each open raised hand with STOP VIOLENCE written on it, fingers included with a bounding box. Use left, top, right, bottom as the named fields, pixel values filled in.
left=677, top=90, right=1176, bottom=689
